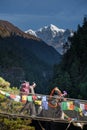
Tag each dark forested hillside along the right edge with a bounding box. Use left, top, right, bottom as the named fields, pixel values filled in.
left=51, top=17, right=87, bottom=99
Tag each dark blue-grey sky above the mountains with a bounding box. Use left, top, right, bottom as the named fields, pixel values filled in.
left=0, top=0, right=87, bottom=31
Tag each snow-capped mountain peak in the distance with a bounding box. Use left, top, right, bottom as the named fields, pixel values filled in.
left=25, top=24, right=73, bottom=54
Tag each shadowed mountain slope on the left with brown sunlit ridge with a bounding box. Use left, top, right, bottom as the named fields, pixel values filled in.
left=0, top=20, right=61, bottom=91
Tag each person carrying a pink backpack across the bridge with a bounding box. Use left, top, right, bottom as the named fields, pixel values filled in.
left=20, top=81, right=36, bottom=116
